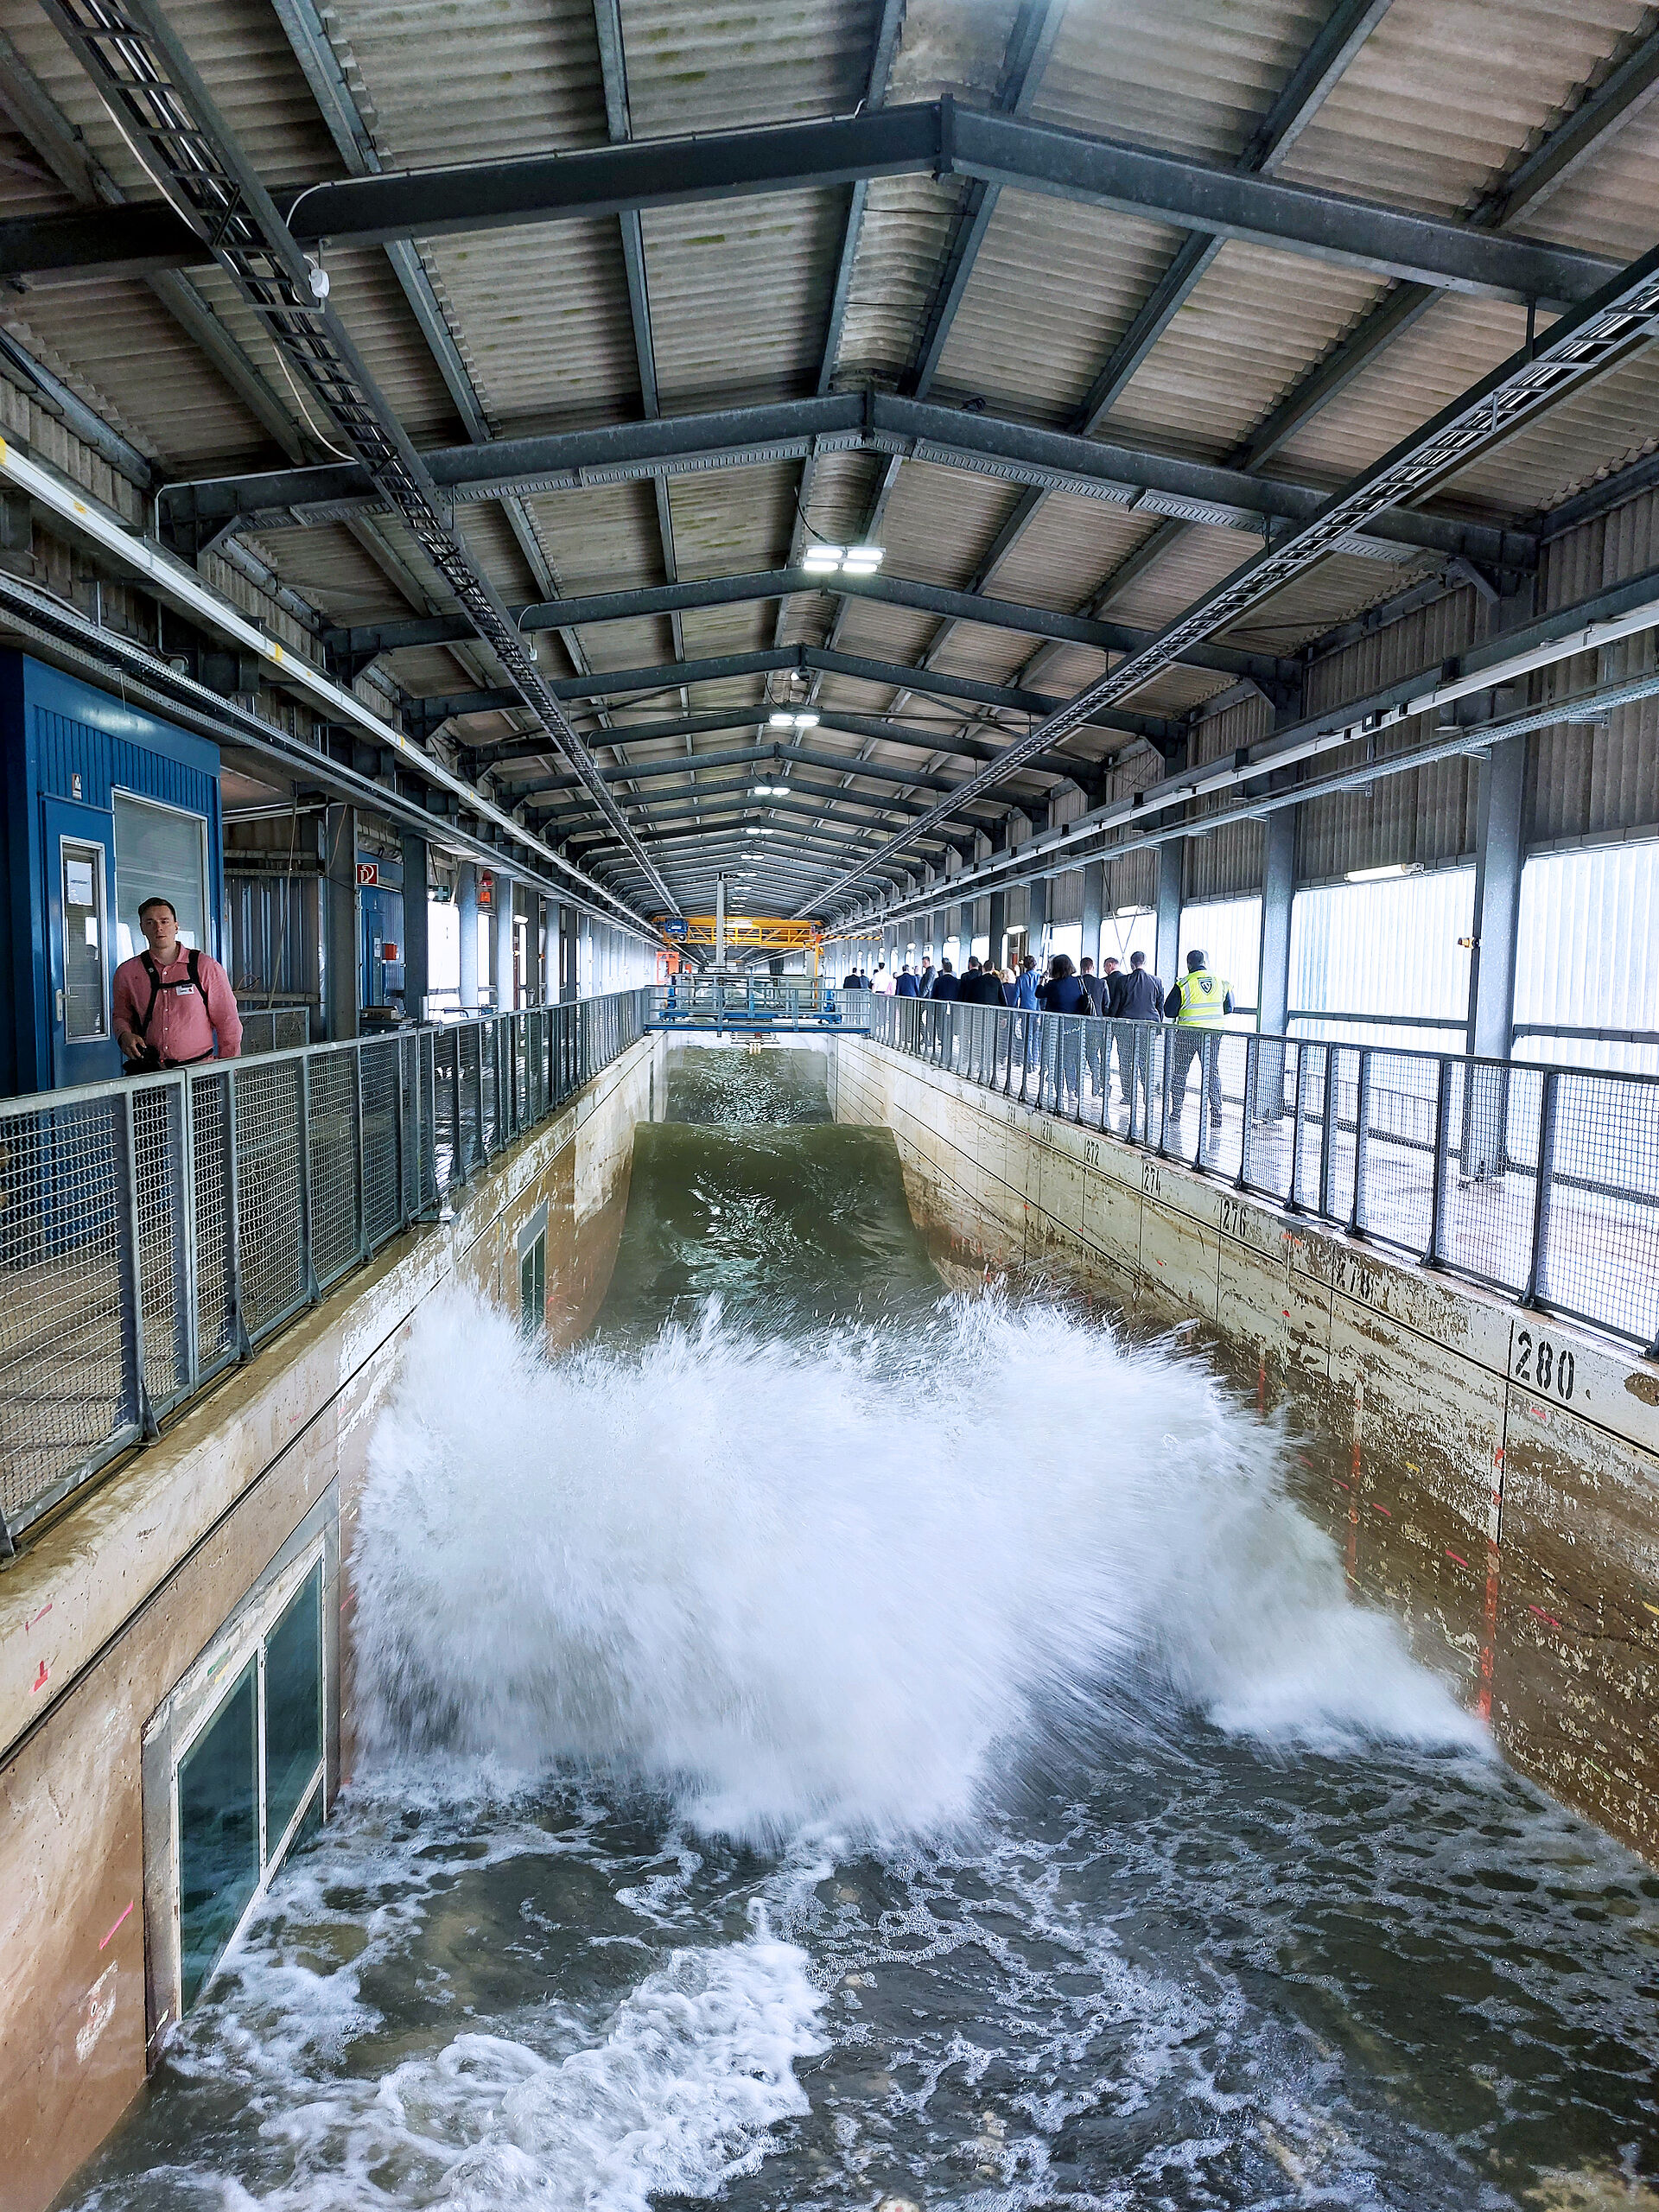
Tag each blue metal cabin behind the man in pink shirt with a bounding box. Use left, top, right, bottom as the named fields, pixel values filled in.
left=0, top=652, right=224, bottom=1097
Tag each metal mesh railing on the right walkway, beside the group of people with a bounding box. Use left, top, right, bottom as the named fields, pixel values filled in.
left=858, top=993, right=1659, bottom=1358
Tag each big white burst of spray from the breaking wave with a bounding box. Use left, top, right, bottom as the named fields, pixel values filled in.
left=354, top=1299, right=1484, bottom=1838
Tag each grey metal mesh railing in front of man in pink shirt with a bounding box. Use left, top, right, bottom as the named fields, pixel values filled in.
left=0, top=991, right=651, bottom=1557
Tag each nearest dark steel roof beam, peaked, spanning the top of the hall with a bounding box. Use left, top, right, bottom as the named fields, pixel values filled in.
left=0, top=98, right=1611, bottom=308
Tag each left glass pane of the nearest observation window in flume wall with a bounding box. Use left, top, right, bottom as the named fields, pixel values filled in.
left=179, top=1659, right=259, bottom=2008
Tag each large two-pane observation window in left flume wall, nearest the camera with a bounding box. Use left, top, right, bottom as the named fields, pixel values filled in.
left=146, top=1541, right=327, bottom=2026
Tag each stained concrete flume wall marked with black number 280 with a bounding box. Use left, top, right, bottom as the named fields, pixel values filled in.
left=836, top=1039, right=1659, bottom=1860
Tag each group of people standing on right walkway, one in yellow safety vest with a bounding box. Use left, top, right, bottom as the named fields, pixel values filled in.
left=841, top=951, right=1232, bottom=1119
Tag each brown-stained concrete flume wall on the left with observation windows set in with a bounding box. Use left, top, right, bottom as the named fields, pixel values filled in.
left=0, top=1038, right=661, bottom=2212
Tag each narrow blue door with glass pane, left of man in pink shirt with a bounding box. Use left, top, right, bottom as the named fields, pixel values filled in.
left=40, top=798, right=122, bottom=1090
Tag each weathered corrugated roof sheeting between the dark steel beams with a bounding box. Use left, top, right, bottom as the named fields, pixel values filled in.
left=0, top=0, right=1659, bottom=915
